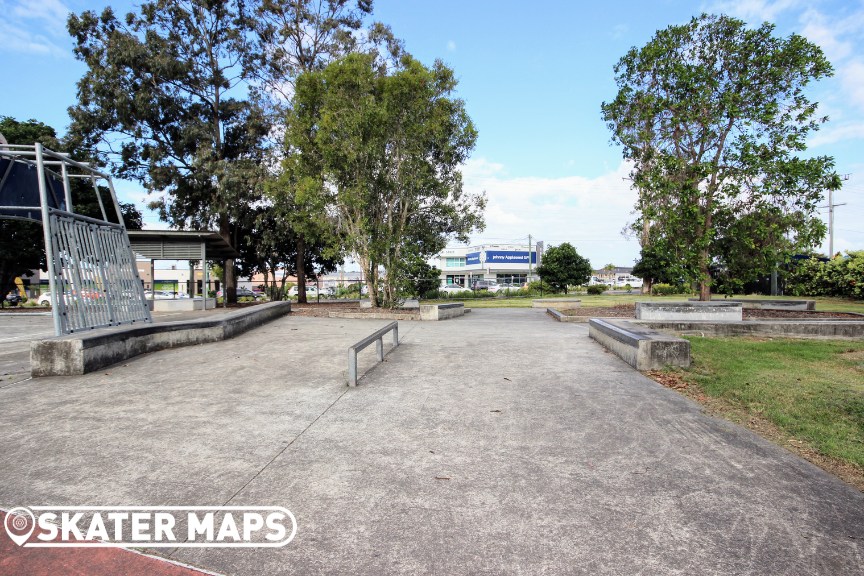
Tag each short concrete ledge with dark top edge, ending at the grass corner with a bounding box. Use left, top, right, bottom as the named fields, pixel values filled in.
left=588, top=318, right=690, bottom=370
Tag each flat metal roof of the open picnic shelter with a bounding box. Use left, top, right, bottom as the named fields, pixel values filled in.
left=128, top=230, right=240, bottom=260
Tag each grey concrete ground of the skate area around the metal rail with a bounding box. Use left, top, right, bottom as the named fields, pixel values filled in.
left=0, top=309, right=864, bottom=575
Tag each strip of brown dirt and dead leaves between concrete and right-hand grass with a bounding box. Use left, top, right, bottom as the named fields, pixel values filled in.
left=645, top=372, right=864, bottom=492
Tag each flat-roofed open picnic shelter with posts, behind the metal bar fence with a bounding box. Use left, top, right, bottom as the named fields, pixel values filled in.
left=129, top=230, right=239, bottom=310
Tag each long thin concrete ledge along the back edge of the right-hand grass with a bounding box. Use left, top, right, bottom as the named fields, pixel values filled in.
left=634, top=319, right=864, bottom=339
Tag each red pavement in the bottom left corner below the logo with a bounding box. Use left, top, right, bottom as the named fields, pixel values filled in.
left=0, top=511, right=212, bottom=576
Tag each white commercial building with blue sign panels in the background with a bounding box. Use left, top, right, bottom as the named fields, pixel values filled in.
left=436, top=242, right=543, bottom=287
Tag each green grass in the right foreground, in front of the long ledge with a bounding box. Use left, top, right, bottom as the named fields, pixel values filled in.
left=649, top=337, right=864, bottom=491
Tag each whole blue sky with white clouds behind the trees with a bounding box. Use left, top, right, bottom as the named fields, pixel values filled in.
left=0, top=0, right=864, bottom=267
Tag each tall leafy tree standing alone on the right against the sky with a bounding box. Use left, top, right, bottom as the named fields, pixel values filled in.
left=602, top=14, right=837, bottom=300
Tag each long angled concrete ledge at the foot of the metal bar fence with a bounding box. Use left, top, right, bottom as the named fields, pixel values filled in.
left=30, top=302, right=291, bottom=377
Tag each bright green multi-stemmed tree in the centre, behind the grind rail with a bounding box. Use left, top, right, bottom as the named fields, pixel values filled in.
left=286, top=54, right=485, bottom=306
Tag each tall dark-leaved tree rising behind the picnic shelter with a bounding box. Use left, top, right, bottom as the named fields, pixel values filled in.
left=68, top=0, right=268, bottom=301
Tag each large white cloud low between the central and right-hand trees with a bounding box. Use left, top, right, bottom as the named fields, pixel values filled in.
left=463, top=158, right=639, bottom=266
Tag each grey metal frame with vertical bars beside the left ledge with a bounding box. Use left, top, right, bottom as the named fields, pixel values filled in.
left=0, top=141, right=152, bottom=336
